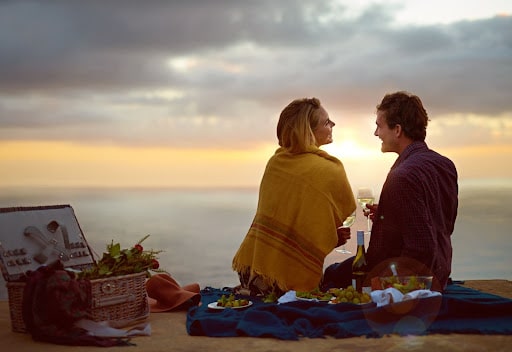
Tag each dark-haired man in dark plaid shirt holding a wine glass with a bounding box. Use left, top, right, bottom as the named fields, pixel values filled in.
left=367, top=92, right=458, bottom=291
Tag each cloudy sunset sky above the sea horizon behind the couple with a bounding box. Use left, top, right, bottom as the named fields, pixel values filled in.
left=0, top=0, right=512, bottom=191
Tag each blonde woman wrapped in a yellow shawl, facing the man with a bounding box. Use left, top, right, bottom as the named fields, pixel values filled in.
left=233, top=98, right=356, bottom=296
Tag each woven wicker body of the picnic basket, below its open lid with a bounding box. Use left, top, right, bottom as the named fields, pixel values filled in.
left=7, top=272, right=149, bottom=332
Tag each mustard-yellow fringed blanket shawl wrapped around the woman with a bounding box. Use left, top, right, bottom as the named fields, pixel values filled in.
left=233, top=148, right=356, bottom=291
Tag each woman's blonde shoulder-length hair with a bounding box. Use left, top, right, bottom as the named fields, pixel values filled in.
left=277, top=98, right=321, bottom=153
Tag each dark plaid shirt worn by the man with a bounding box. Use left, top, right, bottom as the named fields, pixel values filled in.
left=367, top=142, right=458, bottom=288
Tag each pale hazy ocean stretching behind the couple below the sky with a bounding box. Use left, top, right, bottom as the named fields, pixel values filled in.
left=0, top=184, right=512, bottom=300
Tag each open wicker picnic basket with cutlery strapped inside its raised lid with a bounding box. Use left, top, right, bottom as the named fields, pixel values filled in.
left=0, top=205, right=154, bottom=332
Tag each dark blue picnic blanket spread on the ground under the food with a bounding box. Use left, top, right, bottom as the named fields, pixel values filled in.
left=187, top=284, right=512, bottom=340
